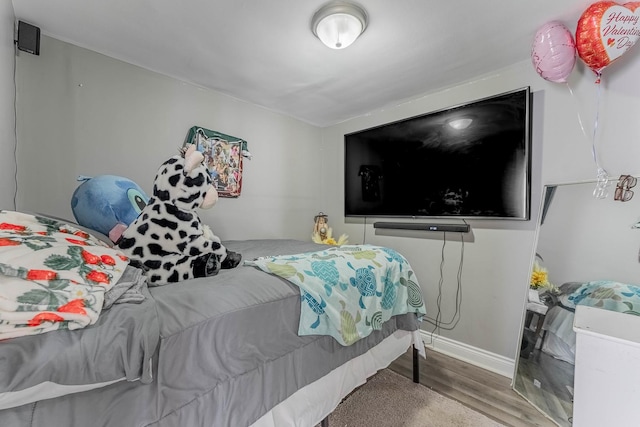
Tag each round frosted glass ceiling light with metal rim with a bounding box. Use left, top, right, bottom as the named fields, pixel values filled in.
left=311, top=1, right=367, bottom=49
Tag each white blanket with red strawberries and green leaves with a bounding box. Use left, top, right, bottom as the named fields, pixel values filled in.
left=0, top=210, right=129, bottom=340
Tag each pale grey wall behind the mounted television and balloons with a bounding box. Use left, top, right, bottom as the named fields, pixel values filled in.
left=323, top=56, right=640, bottom=361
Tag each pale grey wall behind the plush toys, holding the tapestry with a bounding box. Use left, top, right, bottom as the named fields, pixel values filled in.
left=16, top=37, right=323, bottom=240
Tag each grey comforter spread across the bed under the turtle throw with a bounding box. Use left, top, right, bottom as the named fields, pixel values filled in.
left=0, top=240, right=418, bottom=427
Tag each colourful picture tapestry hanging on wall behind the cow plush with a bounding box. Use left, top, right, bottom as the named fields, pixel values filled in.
left=185, top=126, right=249, bottom=197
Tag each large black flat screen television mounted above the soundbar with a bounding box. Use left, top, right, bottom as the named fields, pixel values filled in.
left=344, top=87, right=531, bottom=220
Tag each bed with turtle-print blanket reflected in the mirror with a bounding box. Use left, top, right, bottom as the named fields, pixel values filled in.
left=542, top=280, right=640, bottom=364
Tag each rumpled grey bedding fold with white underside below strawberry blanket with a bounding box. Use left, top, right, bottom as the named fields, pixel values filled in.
left=0, top=272, right=160, bottom=406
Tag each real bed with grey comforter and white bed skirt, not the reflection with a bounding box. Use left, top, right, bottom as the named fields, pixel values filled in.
left=0, top=212, right=424, bottom=427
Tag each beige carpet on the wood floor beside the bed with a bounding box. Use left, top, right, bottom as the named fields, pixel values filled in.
left=329, top=369, right=502, bottom=427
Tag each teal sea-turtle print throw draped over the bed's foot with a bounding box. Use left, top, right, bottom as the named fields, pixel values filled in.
left=245, top=245, right=426, bottom=345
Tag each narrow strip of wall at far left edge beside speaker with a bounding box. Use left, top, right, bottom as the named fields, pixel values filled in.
left=0, top=1, right=16, bottom=209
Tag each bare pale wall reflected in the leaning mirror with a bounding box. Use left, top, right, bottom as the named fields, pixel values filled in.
left=537, top=183, right=640, bottom=286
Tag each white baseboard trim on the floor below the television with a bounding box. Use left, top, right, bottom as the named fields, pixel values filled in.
left=420, top=330, right=515, bottom=379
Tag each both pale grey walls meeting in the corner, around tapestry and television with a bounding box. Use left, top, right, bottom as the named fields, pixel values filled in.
left=17, top=37, right=640, bottom=375
